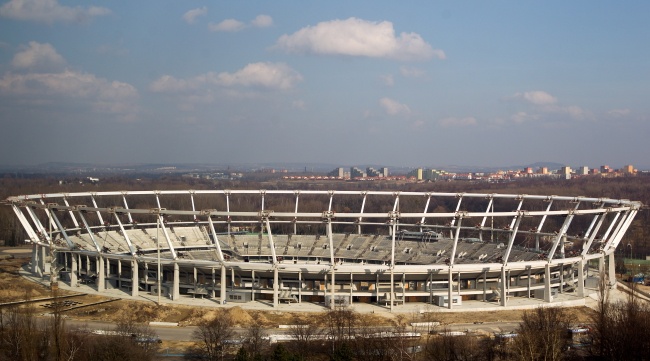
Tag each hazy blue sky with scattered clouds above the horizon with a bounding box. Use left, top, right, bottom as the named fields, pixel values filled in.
left=0, top=0, right=650, bottom=169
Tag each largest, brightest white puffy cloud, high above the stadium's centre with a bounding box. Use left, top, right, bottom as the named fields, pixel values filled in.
left=276, top=18, right=445, bottom=60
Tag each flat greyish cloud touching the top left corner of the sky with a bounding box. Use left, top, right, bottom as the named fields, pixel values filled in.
left=0, top=0, right=111, bottom=23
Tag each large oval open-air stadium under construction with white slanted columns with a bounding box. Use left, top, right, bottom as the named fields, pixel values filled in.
left=5, top=190, right=641, bottom=310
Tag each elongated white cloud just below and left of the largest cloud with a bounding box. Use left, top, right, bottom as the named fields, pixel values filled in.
left=150, top=62, right=302, bottom=92
